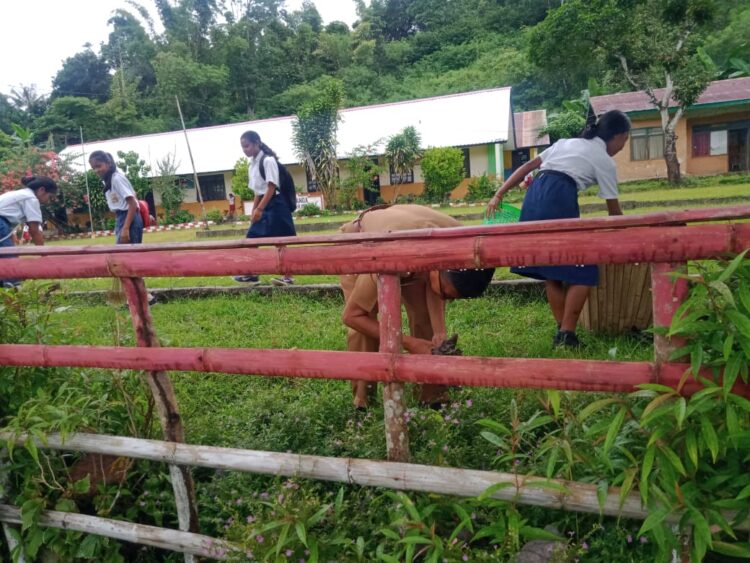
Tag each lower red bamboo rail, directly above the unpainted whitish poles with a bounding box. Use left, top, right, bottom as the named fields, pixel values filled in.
left=0, top=344, right=750, bottom=397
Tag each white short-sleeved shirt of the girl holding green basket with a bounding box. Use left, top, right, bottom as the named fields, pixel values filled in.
left=539, top=137, right=619, bottom=199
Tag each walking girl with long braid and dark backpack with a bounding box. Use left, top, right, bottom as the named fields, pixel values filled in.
left=234, top=131, right=297, bottom=285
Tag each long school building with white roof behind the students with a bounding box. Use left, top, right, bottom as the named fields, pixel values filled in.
left=62, top=87, right=549, bottom=223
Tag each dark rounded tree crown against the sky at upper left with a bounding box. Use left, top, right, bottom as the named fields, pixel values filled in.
left=51, top=44, right=112, bottom=102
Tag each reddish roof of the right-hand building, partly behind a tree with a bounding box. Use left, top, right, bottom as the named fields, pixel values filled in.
left=590, top=77, right=750, bottom=115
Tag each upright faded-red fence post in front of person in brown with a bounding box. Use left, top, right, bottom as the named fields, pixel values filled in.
left=378, top=274, right=409, bottom=461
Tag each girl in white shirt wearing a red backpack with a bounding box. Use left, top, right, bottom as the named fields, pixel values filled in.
left=89, top=151, right=143, bottom=244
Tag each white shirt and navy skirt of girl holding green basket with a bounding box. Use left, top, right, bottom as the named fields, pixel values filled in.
left=510, top=137, right=619, bottom=286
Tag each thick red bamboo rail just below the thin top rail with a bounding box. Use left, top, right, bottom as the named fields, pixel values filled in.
left=0, top=224, right=750, bottom=279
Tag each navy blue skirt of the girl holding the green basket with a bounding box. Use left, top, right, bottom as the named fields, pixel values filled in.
left=510, top=171, right=599, bottom=286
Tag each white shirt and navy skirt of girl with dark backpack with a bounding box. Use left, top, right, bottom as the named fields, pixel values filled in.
left=246, top=150, right=297, bottom=238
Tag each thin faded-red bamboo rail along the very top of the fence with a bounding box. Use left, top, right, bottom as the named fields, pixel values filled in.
left=0, top=205, right=750, bottom=256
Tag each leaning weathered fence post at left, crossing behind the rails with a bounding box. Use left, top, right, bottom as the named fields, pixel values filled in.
left=122, top=278, right=200, bottom=552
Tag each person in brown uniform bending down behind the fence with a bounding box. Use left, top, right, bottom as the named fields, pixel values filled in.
left=341, top=205, right=495, bottom=409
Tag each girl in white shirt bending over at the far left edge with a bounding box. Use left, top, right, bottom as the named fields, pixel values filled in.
left=0, top=176, right=58, bottom=287
